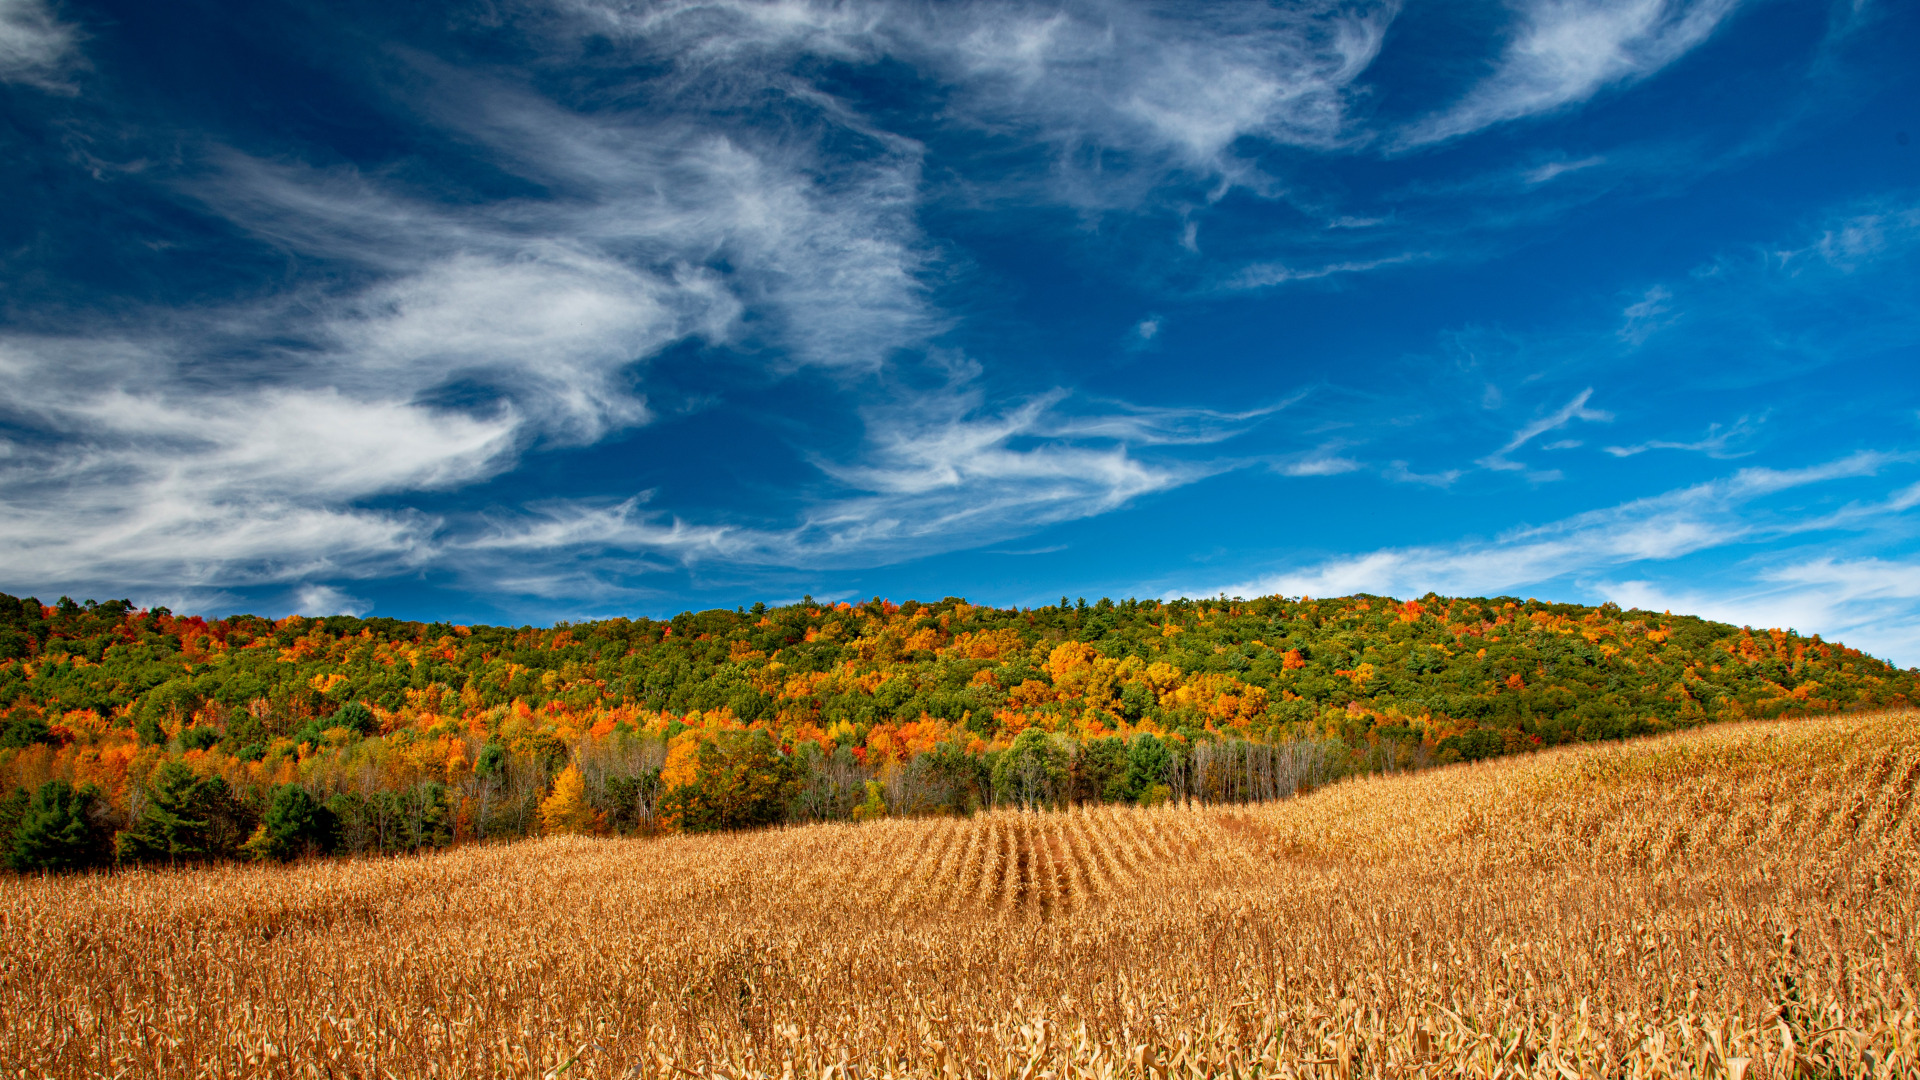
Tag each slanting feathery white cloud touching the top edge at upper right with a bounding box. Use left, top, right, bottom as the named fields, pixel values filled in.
left=1404, top=0, right=1738, bottom=145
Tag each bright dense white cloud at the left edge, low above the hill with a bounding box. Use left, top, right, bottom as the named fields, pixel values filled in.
left=0, top=338, right=516, bottom=586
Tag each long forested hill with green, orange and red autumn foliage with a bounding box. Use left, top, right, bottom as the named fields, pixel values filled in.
left=0, top=596, right=1920, bottom=864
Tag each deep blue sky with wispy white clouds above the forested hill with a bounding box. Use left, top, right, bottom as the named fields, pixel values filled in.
left=0, top=0, right=1920, bottom=667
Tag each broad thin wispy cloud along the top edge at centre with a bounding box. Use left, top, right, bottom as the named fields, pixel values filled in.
left=570, top=0, right=1398, bottom=196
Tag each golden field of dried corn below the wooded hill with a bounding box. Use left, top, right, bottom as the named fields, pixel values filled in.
left=0, top=713, right=1920, bottom=1080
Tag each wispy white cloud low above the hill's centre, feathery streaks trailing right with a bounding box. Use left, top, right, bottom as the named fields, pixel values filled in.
left=447, top=384, right=1271, bottom=594
